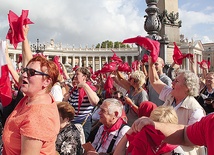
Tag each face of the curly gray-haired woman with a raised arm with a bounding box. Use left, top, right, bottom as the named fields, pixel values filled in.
left=172, top=74, right=188, bottom=96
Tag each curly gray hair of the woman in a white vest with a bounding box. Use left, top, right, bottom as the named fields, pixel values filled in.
left=178, top=70, right=200, bottom=97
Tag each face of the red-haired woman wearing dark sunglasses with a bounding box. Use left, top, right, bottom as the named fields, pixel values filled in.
left=21, top=61, right=47, bottom=96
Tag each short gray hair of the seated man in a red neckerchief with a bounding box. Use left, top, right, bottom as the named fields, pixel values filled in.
left=103, top=98, right=123, bottom=118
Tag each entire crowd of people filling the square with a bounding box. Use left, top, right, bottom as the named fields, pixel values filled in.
left=1, top=25, right=214, bottom=155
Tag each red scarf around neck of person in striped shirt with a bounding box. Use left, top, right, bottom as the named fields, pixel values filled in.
left=70, top=81, right=96, bottom=115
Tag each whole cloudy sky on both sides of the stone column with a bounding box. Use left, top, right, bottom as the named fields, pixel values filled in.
left=0, top=0, right=214, bottom=47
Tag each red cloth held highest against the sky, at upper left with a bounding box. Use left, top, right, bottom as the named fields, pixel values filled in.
left=6, top=10, right=33, bottom=49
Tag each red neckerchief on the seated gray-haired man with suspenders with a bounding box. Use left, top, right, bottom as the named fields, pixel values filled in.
left=101, top=118, right=124, bottom=145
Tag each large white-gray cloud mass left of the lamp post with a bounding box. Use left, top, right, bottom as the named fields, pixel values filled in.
left=0, top=0, right=146, bottom=46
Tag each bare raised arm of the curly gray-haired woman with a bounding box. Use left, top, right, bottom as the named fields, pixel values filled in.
left=148, top=56, right=166, bottom=94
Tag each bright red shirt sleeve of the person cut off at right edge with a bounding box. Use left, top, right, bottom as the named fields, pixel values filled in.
left=186, top=113, right=214, bottom=155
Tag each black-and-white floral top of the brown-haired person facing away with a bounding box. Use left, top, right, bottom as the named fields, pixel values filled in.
left=56, top=123, right=83, bottom=155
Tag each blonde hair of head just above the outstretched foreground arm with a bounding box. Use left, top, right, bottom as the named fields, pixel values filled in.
left=150, top=106, right=178, bottom=124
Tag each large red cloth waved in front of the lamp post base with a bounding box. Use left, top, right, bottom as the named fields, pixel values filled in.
left=123, top=36, right=160, bottom=63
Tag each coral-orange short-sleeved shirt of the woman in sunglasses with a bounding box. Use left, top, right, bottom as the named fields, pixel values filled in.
left=2, top=97, right=60, bottom=155
